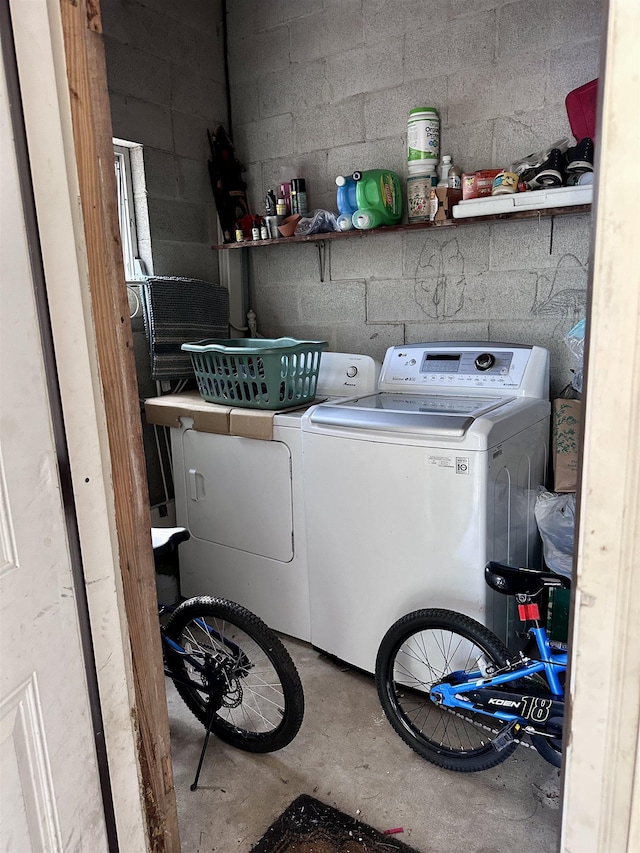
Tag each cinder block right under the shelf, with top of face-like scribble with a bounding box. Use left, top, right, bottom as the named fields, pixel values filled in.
left=402, top=223, right=491, bottom=279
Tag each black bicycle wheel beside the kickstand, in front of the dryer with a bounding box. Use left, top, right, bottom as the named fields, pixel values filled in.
left=165, top=596, right=304, bottom=752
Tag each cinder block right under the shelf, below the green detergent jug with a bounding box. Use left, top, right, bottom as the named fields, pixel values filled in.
left=331, top=233, right=402, bottom=281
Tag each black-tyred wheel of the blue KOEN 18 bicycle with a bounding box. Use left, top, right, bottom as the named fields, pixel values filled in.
left=376, top=610, right=517, bottom=773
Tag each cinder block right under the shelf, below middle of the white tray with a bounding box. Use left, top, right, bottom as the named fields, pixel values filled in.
left=489, top=219, right=555, bottom=270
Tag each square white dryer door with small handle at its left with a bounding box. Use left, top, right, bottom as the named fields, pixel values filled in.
left=183, top=429, right=293, bottom=563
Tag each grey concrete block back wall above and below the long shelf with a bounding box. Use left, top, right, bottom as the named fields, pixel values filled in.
left=229, top=0, right=601, bottom=393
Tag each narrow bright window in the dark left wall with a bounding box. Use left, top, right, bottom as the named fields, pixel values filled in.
left=113, top=139, right=152, bottom=282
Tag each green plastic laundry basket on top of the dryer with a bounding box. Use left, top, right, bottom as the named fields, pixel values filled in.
left=182, top=338, right=329, bottom=409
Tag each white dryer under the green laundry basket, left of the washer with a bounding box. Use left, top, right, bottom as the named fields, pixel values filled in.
left=171, top=352, right=380, bottom=641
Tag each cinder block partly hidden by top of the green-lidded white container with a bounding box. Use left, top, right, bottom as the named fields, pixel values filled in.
left=364, top=76, right=447, bottom=143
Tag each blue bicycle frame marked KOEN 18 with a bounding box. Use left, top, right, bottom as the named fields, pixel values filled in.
left=430, top=623, right=567, bottom=725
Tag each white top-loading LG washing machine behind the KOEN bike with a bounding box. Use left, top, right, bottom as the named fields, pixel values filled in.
left=302, top=342, right=550, bottom=672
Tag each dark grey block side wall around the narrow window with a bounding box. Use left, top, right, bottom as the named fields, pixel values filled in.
left=101, top=0, right=227, bottom=281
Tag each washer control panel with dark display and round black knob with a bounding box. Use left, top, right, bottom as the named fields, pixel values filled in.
left=379, top=341, right=549, bottom=398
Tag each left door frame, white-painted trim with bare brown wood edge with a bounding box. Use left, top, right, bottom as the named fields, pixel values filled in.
left=9, top=0, right=180, bottom=853
